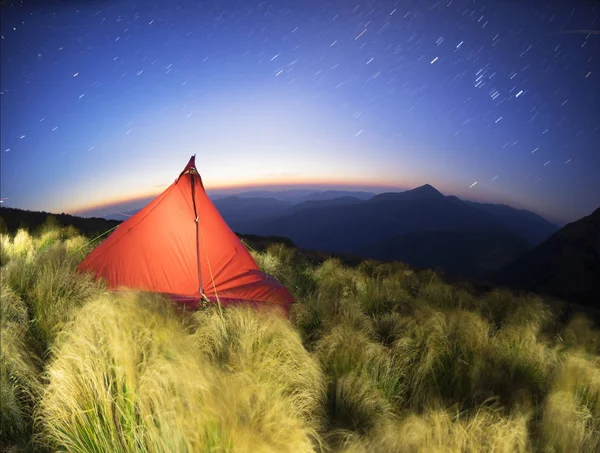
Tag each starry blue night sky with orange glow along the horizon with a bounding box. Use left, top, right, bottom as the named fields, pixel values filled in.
left=0, top=0, right=600, bottom=222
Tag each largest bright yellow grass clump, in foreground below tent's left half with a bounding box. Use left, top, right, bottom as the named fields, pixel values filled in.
left=37, top=294, right=217, bottom=452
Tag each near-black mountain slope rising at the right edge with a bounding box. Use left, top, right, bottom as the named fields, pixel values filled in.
left=490, top=208, right=600, bottom=305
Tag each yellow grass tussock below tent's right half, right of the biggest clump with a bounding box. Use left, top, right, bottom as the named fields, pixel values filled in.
left=193, top=307, right=325, bottom=433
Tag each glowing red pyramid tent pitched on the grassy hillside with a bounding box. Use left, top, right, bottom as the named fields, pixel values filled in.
left=78, top=156, right=294, bottom=313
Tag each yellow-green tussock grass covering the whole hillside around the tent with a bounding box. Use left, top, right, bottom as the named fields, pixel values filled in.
left=0, top=223, right=600, bottom=453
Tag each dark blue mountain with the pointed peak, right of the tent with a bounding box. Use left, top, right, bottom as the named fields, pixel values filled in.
left=253, top=184, right=557, bottom=278
